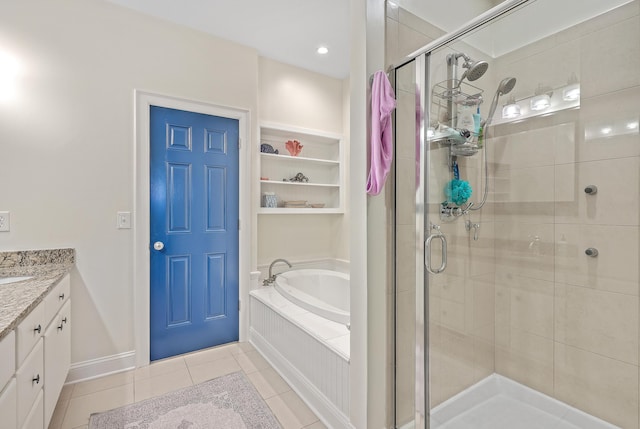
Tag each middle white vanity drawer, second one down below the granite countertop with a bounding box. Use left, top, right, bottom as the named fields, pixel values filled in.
left=16, top=339, right=44, bottom=427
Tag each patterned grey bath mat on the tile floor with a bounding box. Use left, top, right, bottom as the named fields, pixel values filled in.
left=89, top=372, right=280, bottom=429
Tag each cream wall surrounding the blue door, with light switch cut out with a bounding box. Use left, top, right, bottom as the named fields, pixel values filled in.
left=0, top=0, right=258, bottom=362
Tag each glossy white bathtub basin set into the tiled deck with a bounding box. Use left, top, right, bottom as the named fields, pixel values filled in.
left=275, top=270, right=351, bottom=326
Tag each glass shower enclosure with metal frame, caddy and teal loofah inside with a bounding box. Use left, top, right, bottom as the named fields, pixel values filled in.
left=393, top=0, right=640, bottom=429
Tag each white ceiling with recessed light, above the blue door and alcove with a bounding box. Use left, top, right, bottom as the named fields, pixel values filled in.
left=108, top=0, right=350, bottom=79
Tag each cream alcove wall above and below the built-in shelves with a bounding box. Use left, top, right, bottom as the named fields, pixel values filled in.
left=257, top=58, right=349, bottom=265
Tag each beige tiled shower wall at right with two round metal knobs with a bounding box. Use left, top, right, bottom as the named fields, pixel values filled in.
left=490, top=1, right=640, bottom=428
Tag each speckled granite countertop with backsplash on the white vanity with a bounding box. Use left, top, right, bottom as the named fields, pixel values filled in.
left=0, top=249, right=75, bottom=340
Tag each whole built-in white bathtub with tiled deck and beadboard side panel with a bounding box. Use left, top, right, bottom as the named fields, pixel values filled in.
left=249, top=269, right=352, bottom=428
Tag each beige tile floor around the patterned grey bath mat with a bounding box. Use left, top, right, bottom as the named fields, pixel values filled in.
left=49, top=343, right=326, bottom=429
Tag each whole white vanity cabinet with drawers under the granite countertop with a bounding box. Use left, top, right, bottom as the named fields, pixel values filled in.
left=0, top=275, right=71, bottom=429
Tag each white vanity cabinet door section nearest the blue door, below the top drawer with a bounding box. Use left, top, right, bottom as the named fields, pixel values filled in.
left=44, top=300, right=71, bottom=426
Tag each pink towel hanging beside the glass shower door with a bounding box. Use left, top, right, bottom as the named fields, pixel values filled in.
left=367, top=71, right=396, bottom=195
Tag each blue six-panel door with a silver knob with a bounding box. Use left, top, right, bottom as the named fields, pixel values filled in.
left=150, top=106, right=239, bottom=360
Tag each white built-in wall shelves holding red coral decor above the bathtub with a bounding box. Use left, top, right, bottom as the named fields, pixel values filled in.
left=258, top=123, right=345, bottom=214
